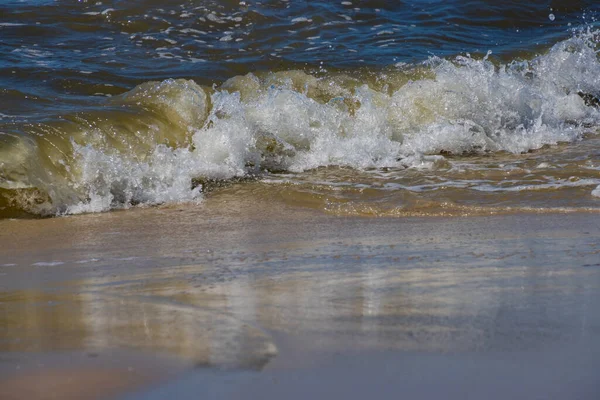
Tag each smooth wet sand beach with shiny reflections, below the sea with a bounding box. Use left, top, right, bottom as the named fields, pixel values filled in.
left=0, top=185, right=600, bottom=399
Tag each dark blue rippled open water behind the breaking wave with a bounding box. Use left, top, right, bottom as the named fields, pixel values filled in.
left=0, top=0, right=600, bottom=115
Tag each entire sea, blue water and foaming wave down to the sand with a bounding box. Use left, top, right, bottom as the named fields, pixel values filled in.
left=0, top=0, right=600, bottom=218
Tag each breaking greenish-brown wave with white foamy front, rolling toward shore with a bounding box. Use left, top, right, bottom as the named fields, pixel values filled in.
left=0, top=30, right=600, bottom=215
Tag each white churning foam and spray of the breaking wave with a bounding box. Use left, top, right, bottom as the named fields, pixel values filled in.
left=4, top=31, right=600, bottom=213
